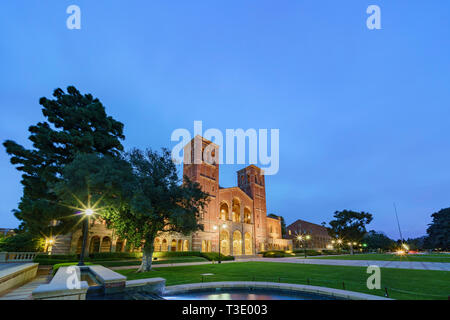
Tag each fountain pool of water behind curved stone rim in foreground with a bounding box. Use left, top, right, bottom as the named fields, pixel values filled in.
left=163, top=288, right=336, bottom=300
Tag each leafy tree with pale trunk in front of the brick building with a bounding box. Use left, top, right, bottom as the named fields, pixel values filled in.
left=57, top=149, right=209, bottom=271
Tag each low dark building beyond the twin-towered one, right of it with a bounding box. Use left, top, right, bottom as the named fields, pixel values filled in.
left=286, top=220, right=331, bottom=250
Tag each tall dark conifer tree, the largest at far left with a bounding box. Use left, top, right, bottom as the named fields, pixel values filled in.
left=3, top=86, right=125, bottom=235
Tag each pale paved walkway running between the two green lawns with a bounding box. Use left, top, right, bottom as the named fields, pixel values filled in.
left=110, top=257, right=450, bottom=271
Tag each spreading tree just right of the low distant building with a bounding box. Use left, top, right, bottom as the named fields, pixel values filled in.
left=328, top=210, right=373, bottom=254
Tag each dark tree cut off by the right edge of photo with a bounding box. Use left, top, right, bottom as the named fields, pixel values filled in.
left=426, top=208, right=450, bottom=250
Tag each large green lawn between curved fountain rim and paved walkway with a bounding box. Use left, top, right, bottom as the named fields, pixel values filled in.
left=118, top=262, right=450, bottom=300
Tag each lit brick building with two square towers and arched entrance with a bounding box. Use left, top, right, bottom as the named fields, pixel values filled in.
left=47, top=136, right=292, bottom=256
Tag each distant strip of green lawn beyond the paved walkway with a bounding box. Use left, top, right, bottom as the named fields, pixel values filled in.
left=308, top=253, right=450, bottom=263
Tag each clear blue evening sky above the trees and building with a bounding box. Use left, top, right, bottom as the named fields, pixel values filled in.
left=0, top=0, right=450, bottom=238
